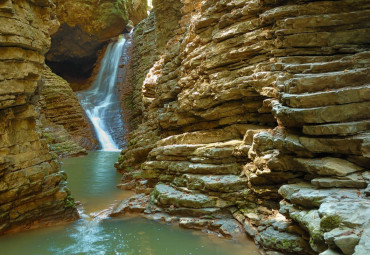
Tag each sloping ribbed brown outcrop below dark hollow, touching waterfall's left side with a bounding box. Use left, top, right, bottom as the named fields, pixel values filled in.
left=40, top=66, right=98, bottom=157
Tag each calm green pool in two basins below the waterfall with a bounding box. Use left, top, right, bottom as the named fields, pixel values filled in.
left=0, top=151, right=259, bottom=255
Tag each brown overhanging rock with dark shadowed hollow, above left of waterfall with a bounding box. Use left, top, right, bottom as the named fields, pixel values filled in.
left=46, top=0, right=148, bottom=87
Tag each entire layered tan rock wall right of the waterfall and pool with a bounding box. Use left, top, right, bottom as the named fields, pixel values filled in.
left=114, top=0, right=370, bottom=254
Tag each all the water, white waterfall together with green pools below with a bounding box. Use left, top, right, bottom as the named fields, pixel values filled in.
left=0, top=30, right=259, bottom=255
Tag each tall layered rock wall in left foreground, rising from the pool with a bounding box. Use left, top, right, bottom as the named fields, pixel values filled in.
left=0, top=1, right=78, bottom=234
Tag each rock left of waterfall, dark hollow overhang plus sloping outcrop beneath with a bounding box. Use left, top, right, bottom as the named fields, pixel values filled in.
left=40, top=0, right=148, bottom=153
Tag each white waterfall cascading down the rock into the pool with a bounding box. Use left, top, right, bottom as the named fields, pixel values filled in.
left=77, top=36, right=126, bottom=151
